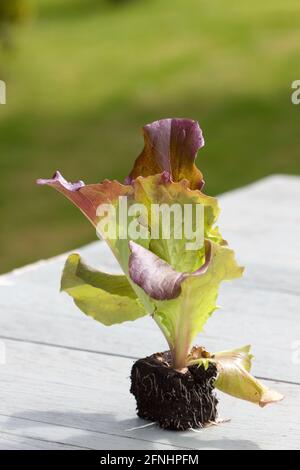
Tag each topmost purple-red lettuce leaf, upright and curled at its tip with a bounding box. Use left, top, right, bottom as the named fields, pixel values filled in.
left=126, top=119, right=204, bottom=189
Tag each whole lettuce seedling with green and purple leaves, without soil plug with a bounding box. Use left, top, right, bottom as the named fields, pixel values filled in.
left=38, top=119, right=283, bottom=406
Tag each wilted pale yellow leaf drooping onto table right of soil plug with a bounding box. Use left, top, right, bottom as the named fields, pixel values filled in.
left=213, top=346, right=284, bottom=408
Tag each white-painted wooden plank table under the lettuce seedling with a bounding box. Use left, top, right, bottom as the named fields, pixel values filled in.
left=0, top=176, right=300, bottom=450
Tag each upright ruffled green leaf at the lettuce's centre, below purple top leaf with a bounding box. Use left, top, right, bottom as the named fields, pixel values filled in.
left=132, top=173, right=225, bottom=272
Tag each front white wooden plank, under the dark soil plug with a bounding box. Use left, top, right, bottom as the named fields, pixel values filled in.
left=0, top=341, right=300, bottom=449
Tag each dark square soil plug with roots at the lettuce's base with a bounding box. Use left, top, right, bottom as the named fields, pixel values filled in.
left=130, top=352, right=218, bottom=430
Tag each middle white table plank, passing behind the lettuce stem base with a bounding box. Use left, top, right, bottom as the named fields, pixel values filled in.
left=0, top=282, right=300, bottom=382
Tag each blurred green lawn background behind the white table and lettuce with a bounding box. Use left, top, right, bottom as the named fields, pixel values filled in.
left=0, top=0, right=300, bottom=272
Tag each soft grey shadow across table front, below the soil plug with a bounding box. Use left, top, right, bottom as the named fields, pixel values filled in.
left=4, top=411, right=260, bottom=450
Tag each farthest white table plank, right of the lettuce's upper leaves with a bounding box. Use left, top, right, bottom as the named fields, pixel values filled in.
left=219, top=176, right=300, bottom=274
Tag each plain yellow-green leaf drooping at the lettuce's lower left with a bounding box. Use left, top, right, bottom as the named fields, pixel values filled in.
left=61, top=254, right=147, bottom=326
